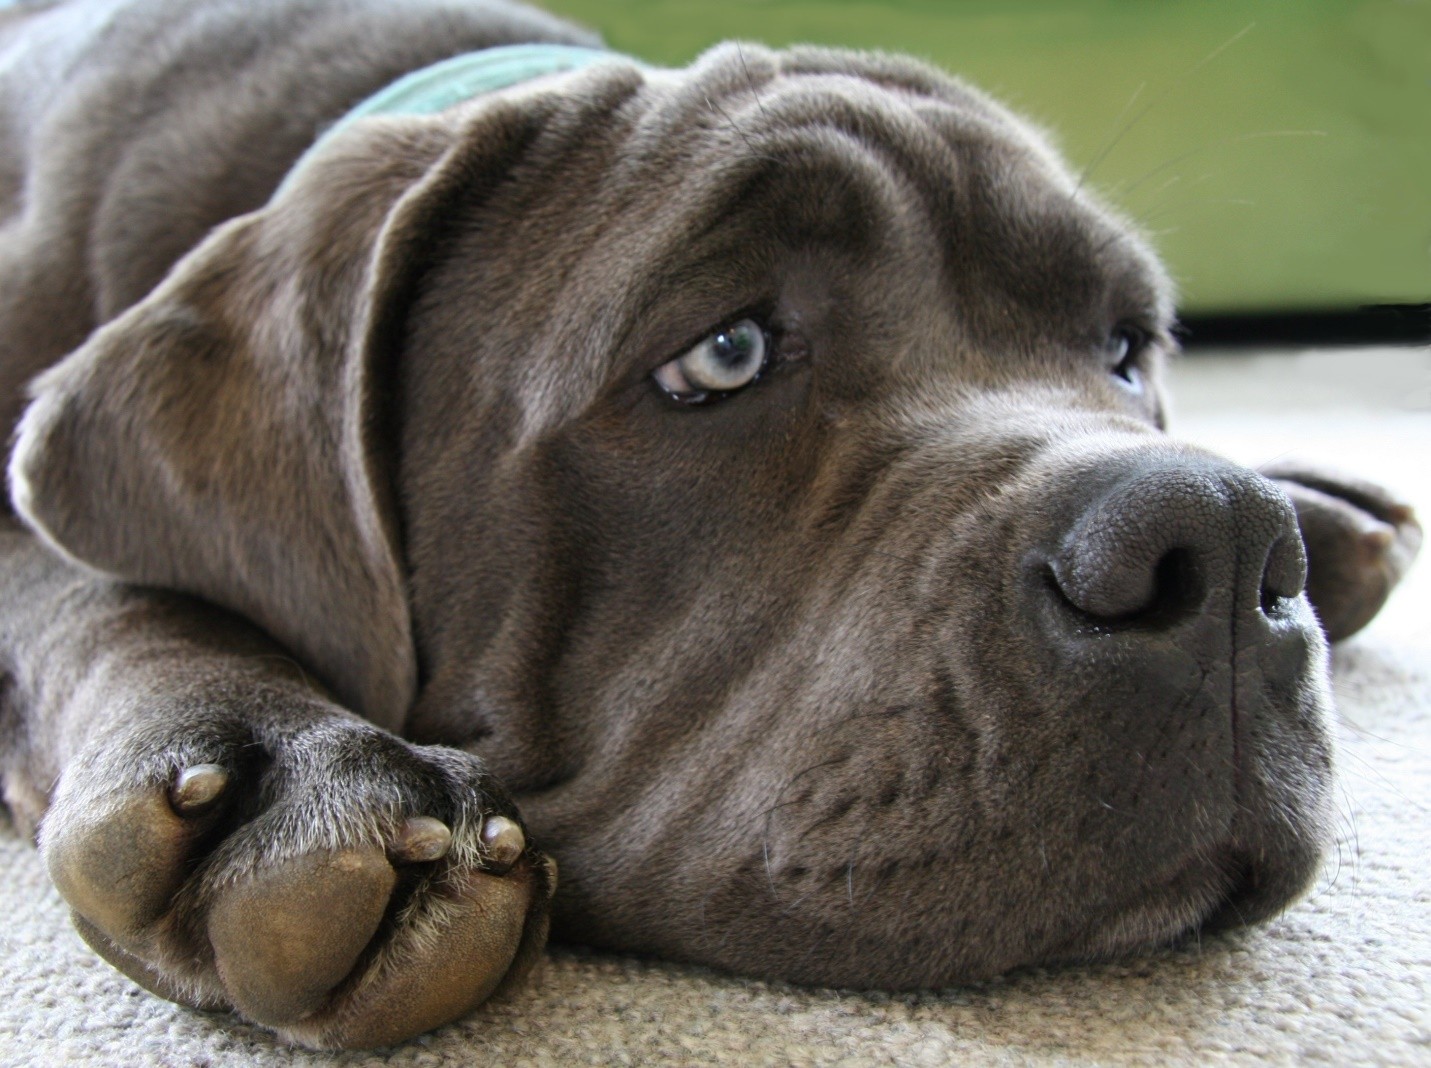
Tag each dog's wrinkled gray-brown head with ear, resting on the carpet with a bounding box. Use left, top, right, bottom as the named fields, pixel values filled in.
left=13, top=47, right=1331, bottom=986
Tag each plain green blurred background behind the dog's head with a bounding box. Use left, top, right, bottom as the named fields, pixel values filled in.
left=538, top=0, right=1431, bottom=315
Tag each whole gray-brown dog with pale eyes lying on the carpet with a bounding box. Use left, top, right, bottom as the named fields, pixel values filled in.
left=0, top=0, right=1420, bottom=1047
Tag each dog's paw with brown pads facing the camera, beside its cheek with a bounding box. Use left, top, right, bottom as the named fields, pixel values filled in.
left=40, top=695, right=555, bottom=1048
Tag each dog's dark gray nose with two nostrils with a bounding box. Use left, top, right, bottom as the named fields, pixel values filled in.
left=1049, top=457, right=1307, bottom=628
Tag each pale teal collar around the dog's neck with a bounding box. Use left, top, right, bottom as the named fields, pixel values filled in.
left=277, top=43, right=624, bottom=192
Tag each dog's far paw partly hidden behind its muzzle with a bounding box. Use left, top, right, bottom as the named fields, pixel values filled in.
left=1262, top=462, right=1421, bottom=641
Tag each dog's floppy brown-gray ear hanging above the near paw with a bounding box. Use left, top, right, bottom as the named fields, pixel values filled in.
left=10, top=100, right=542, bottom=727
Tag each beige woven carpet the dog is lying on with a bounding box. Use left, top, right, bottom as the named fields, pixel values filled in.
left=0, top=349, right=1431, bottom=1067
